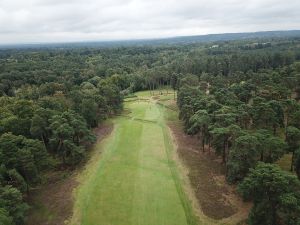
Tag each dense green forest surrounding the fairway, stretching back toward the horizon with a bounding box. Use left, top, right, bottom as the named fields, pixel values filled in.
left=0, top=37, right=300, bottom=225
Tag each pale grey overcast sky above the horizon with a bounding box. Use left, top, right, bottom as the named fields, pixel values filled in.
left=0, top=0, right=300, bottom=44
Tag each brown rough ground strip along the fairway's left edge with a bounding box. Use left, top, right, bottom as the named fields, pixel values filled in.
left=26, top=123, right=113, bottom=225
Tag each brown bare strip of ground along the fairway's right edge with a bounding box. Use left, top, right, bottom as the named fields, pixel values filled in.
left=168, top=121, right=249, bottom=221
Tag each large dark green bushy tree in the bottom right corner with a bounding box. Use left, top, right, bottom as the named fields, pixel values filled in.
left=238, top=163, right=300, bottom=225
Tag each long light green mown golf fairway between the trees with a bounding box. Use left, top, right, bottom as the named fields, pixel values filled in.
left=71, top=92, right=197, bottom=225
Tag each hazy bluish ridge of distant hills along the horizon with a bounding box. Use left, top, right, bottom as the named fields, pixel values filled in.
left=0, top=30, right=300, bottom=49
